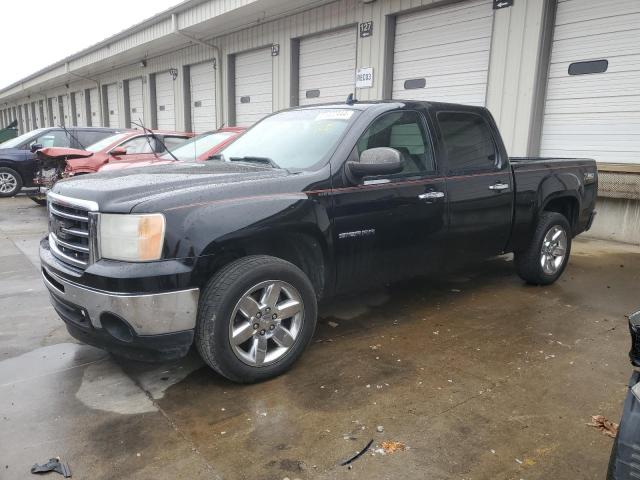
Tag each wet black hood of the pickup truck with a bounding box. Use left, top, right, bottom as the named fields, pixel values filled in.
left=52, top=161, right=290, bottom=213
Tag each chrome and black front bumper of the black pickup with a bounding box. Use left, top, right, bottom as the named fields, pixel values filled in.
left=40, top=247, right=199, bottom=360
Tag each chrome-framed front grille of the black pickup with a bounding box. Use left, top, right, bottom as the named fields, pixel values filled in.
left=47, top=192, right=98, bottom=270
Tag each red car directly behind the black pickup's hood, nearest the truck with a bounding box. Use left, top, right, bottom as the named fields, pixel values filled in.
left=98, top=127, right=246, bottom=172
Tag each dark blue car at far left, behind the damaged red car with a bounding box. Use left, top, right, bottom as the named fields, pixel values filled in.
left=0, top=127, right=120, bottom=197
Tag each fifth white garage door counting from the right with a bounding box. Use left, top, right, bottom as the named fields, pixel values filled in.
left=189, top=62, right=217, bottom=133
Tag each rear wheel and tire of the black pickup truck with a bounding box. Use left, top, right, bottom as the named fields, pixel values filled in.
left=515, top=212, right=572, bottom=285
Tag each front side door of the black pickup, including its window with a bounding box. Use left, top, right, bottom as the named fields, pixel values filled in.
left=333, top=110, right=446, bottom=293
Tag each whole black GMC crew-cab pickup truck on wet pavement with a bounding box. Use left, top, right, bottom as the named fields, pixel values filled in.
left=40, top=101, right=597, bottom=382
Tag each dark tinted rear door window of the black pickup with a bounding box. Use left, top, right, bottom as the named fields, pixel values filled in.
left=438, top=112, right=500, bottom=172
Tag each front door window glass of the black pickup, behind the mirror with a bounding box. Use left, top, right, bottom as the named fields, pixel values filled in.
left=357, top=111, right=436, bottom=175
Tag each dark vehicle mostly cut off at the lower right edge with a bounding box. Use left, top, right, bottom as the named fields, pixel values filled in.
left=607, top=311, right=640, bottom=480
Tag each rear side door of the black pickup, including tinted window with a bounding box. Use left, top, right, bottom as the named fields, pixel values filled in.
left=436, top=111, right=513, bottom=260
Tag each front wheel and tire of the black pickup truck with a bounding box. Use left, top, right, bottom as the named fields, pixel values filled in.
left=195, top=255, right=318, bottom=383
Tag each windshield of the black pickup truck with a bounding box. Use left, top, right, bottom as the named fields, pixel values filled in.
left=222, top=108, right=356, bottom=169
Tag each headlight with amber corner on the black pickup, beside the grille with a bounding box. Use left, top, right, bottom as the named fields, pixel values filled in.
left=98, top=213, right=165, bottom=262
